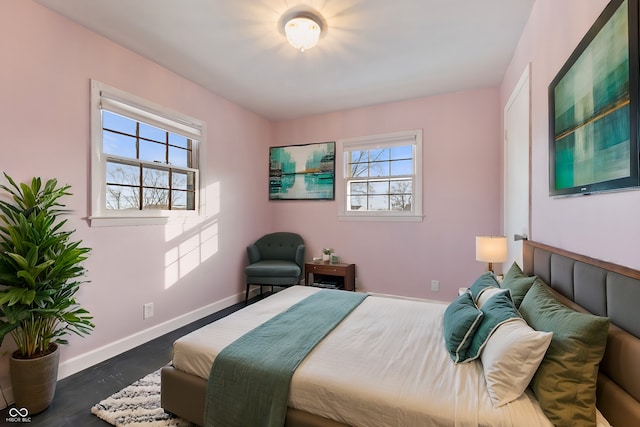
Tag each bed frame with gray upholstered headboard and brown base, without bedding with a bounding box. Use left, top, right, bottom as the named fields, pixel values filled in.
left=161, top=241, right=640, bottom=427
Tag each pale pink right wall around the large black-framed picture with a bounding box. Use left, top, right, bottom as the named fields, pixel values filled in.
left=501, top=0, right=640, bottom=268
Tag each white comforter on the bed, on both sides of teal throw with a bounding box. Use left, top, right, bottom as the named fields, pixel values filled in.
left=173, top=286, right=551, bottom=427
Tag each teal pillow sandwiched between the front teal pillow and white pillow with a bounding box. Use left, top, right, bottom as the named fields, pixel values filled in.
left=467, top=289, right=522, bottom=360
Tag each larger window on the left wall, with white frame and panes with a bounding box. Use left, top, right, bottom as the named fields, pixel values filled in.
left=91, top=81, right=203, bottom=226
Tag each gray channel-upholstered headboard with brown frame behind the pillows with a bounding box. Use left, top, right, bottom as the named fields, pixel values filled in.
left=523, top=241, right=640, bottom=427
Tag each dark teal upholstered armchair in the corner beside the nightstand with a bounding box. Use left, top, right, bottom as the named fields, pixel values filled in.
left=244, top=231, right=305, bottom=304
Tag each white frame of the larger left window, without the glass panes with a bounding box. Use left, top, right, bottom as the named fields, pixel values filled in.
left=89, top=80, right=206, bottom=227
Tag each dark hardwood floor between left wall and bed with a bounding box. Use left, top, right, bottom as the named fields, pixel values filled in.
left=0, top=292, right=262, bottom=427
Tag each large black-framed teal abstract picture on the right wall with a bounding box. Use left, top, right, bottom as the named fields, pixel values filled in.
left=549, top=0, right=639, bottom=196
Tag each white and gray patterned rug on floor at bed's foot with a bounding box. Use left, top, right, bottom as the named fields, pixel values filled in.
left=91, top=370, right=193, bottom=427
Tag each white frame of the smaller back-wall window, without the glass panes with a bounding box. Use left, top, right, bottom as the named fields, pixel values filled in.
left=336, top=129, right=423, bottom=221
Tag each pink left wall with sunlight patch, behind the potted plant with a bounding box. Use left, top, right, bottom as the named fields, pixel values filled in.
left=0, top=0, right=272, bottom=385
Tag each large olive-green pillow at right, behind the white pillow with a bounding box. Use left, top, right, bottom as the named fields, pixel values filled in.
left=520, top=279, right=609, bottom=426
